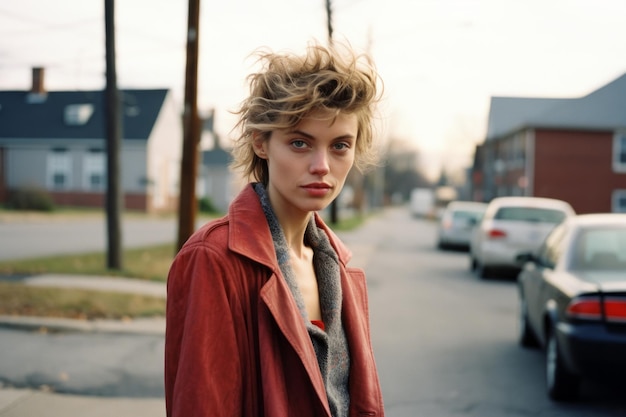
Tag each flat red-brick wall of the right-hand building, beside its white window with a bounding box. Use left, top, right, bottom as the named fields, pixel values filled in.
left=533, top=129, right=626, bottom=214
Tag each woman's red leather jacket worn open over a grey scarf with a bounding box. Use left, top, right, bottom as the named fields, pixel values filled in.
left=165, top=185, right=384, bottom=417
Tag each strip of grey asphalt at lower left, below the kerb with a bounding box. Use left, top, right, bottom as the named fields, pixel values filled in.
left=0, top=328, right=164, bottom=398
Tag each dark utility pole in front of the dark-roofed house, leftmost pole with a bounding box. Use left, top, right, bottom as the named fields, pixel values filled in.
left=104, top=0, right=123, bottom=270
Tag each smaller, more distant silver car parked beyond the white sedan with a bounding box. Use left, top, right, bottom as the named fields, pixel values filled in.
left=437, top=201, right=487, bottom=250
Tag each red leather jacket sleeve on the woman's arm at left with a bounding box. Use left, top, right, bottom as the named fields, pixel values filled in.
left=165, top=243, right=243, bottom=417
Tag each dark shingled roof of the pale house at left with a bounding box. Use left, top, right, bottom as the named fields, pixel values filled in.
left=0, top=89, right=168, bottom=140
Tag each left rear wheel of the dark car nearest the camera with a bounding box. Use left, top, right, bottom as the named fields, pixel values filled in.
left=546, top=329, right=580, bottom=401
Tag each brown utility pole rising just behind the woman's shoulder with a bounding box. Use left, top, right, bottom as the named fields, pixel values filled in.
left=177, top=0, right=200, bottom=250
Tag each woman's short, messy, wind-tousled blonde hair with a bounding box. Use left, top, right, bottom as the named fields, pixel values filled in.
left=232, top=44, right=379, bottom=185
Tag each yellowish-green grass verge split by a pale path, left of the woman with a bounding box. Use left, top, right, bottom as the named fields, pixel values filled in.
left=0, top=243, right=175, bottom=319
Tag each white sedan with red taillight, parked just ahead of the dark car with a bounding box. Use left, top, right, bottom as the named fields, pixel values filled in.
left=469, top=197, right=575, bottom=278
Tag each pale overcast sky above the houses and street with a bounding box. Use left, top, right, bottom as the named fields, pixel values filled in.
left=0, top=0, right=626, bottom=177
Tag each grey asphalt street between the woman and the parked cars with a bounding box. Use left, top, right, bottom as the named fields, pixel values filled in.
left=356, top=209, right=626, bottom=417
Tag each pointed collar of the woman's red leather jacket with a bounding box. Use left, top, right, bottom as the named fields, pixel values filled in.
left=228, top=184, right=352, bottom=272
